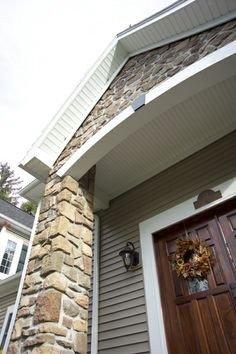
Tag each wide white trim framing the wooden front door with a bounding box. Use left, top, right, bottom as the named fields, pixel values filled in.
left=139, top=177, right=236, bottom=354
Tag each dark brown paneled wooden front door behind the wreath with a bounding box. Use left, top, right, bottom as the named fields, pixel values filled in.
left=154, top=200, right=236, bottom=354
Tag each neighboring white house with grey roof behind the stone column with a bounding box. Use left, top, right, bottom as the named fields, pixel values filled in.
left=0, top=199, right=34, bottom=348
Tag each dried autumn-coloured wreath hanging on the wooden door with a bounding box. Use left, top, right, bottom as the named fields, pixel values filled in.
left=173, top=239, right=214, bottom=279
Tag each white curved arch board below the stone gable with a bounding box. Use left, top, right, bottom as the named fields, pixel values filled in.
left=57, top=41, right=236, bottom=179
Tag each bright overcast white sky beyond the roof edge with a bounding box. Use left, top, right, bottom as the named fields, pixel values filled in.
left=0, top=0, right=174, bottom=186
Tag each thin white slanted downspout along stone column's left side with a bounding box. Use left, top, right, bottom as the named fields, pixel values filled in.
left=4, top=200, right=41, bottom=354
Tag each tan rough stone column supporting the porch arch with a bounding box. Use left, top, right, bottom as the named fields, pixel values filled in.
left=8, top=169, right=95, bottom=354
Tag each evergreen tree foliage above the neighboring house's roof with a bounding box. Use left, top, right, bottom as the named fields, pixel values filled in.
left=0, top=162, right=21, bottom=205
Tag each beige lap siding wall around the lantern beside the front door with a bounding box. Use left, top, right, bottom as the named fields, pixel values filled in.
left=99, top=132, right=236, bottom=354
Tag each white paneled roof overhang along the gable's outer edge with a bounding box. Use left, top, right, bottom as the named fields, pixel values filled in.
left=20, top=0, right=236, bottom=181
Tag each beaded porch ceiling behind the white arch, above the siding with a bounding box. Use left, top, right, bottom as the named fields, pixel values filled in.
left=96, top=76, right=236, bottom=202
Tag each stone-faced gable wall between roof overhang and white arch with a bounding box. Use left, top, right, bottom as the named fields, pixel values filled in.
left=53, top=20, right=236, bottom=169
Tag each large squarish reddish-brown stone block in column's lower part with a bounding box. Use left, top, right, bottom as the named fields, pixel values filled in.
left=34, top=290, right=62, bottom=324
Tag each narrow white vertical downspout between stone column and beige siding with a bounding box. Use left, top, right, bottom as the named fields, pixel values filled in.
left=91, top=214, right=100, bottom=354
